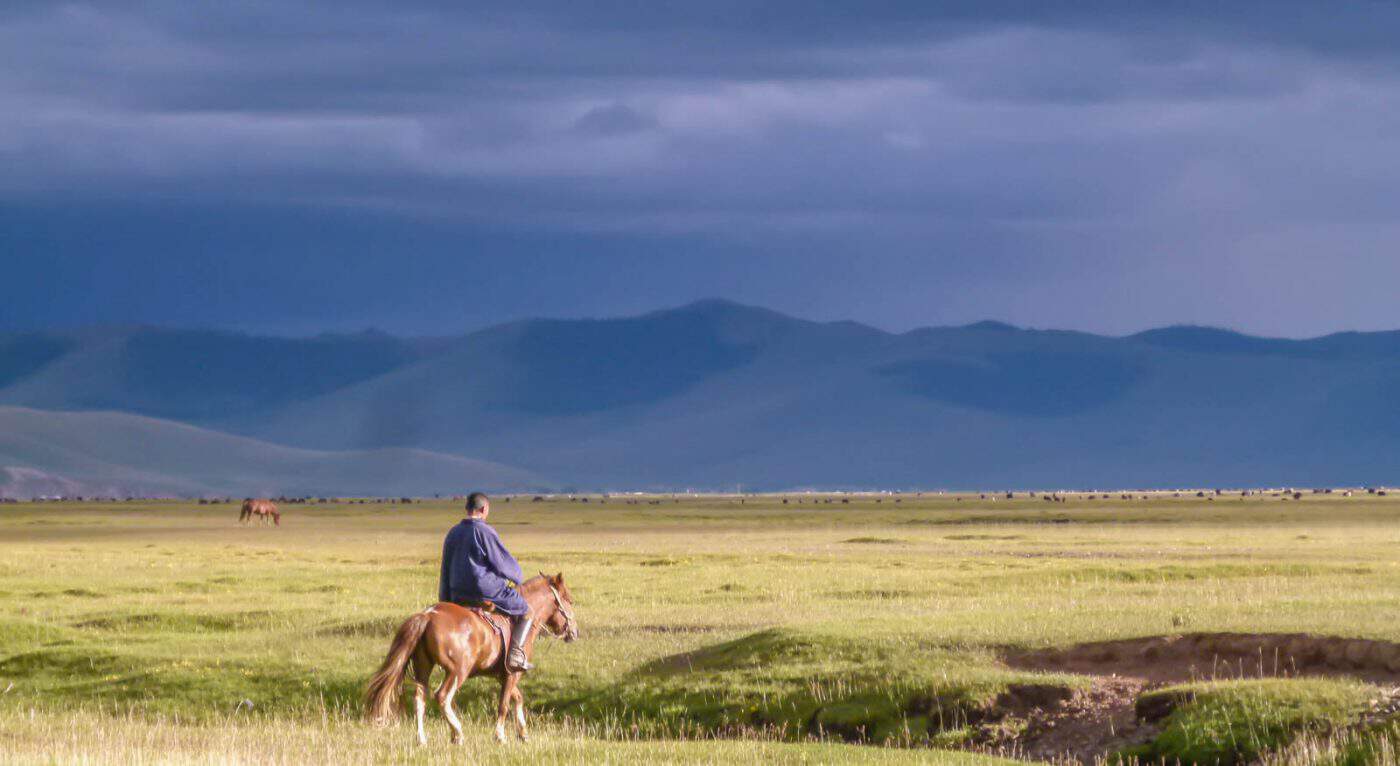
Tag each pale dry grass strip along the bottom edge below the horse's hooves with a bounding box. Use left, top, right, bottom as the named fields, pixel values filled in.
left=0, top=704, right=1014, bottom=766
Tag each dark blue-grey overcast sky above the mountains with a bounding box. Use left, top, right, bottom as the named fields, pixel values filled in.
left=0, top=0, right=1400, bottom=336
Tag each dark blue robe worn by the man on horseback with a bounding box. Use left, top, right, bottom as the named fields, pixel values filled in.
left=438, top=518, right=525, bottom=613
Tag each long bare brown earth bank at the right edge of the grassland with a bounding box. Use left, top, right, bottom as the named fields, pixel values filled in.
left=1002, top=633, right=1400, bottom=685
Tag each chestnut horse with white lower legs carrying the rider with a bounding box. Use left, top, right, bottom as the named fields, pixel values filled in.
left=365, top=574, right=578, bottom=745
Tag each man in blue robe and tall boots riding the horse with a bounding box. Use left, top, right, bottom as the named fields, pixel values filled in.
left=438, top=492, right=535, bottom=672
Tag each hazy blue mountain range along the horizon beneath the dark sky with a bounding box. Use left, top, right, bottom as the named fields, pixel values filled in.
left=0, top=301, right=1400, bottom=494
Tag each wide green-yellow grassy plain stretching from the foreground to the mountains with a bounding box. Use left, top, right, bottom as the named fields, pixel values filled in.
left=0, top=494, right=1400, bottom=763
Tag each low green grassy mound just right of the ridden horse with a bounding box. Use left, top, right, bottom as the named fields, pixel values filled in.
left=561, top=629, right=1041, bottom=745
